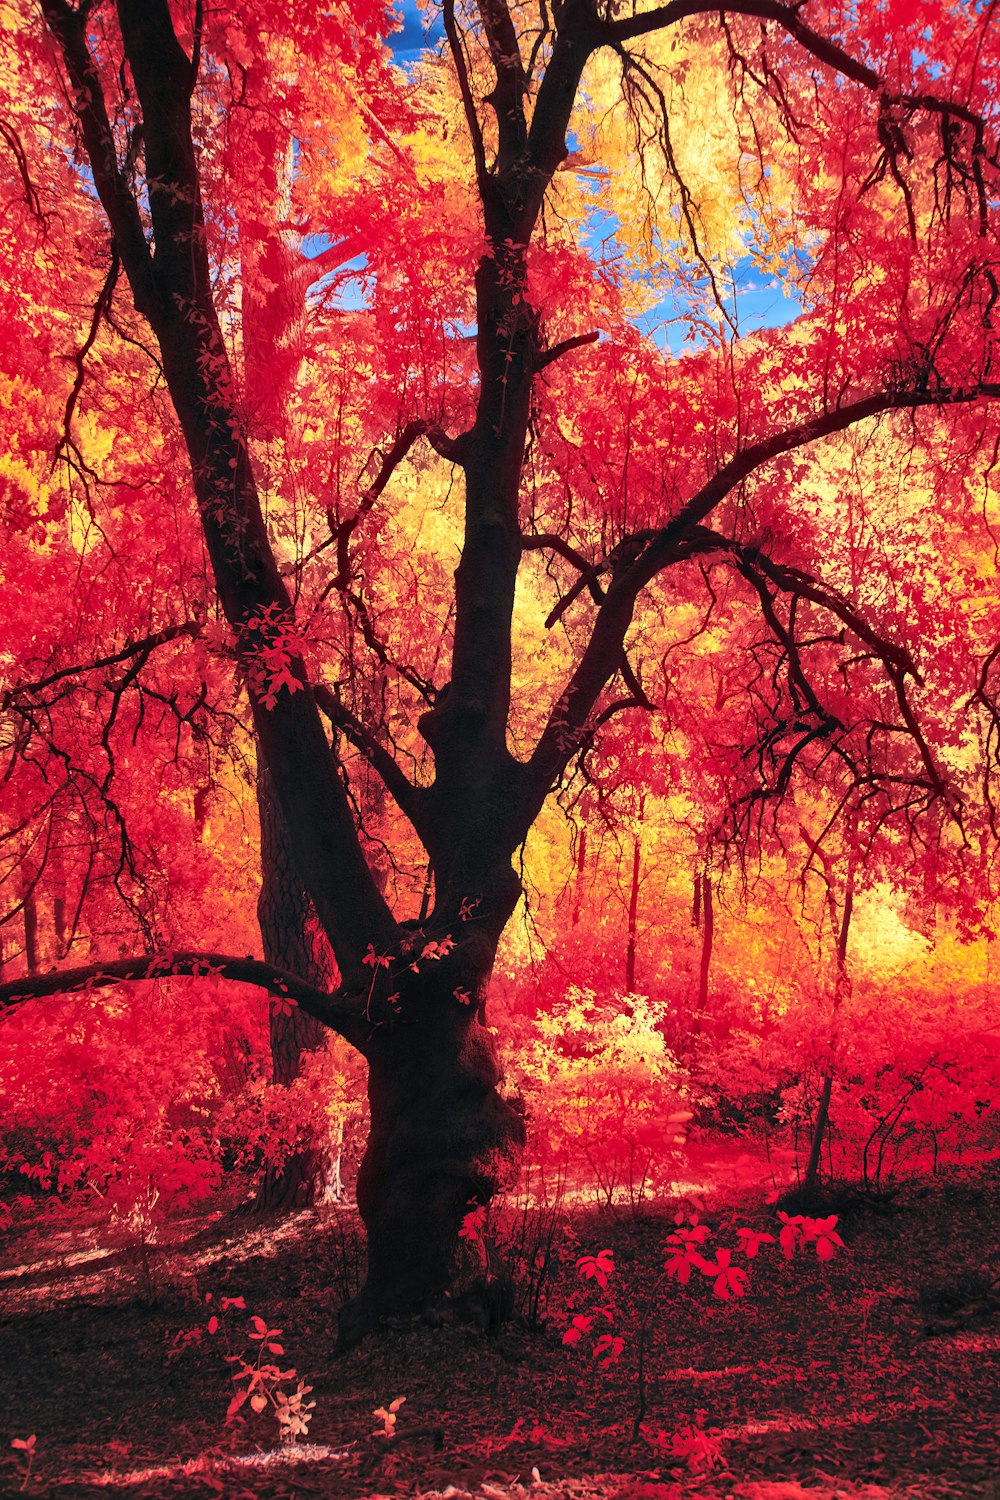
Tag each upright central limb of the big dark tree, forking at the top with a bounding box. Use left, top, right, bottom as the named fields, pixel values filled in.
left=434, top=0, right=605, bottom=774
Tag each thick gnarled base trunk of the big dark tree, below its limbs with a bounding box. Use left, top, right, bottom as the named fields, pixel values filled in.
left=340, top=954, right=525, bottom=1344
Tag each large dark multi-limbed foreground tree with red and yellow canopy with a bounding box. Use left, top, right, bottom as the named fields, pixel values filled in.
left=0, top=0, right=1000, bottom=1337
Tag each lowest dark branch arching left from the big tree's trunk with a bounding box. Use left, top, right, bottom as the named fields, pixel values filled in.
left=0, top=950, right=369, bottom=1047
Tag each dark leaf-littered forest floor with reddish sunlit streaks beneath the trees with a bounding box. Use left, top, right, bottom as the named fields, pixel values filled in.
left=0, top=1163, right=1000, bottom=1500
